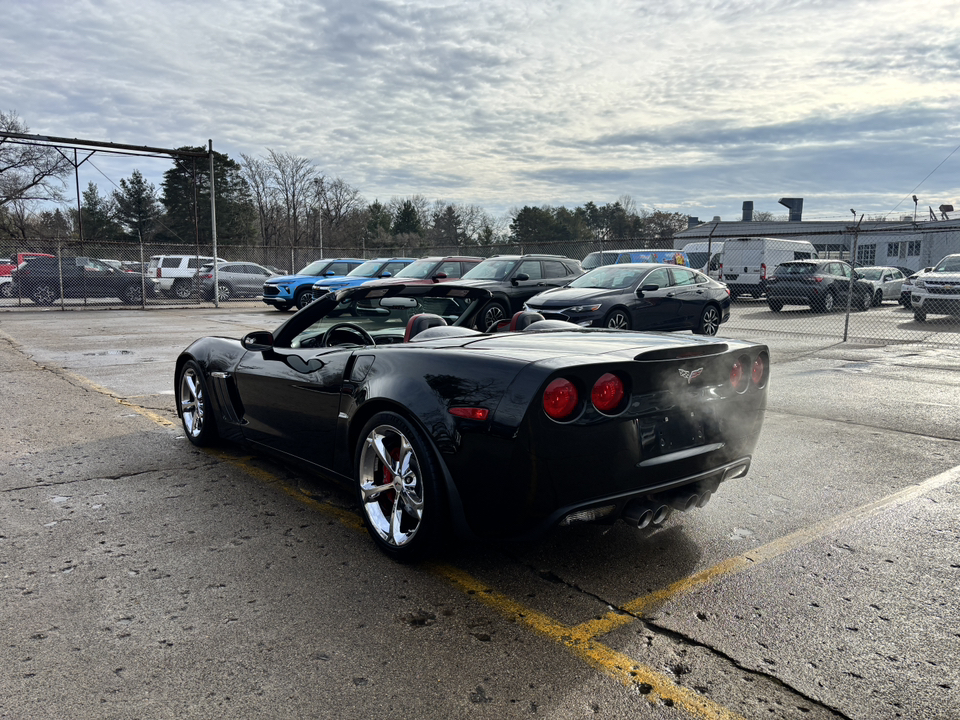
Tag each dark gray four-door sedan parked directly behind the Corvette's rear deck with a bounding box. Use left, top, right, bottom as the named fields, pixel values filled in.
left=525, top=263, right=730, bottom=335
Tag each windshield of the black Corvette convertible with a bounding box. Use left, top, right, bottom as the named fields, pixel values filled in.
left=290, top=285, right=480, bottom=348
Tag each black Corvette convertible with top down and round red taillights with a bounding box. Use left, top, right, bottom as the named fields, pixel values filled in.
left=175, top=283, right=769, bottom=559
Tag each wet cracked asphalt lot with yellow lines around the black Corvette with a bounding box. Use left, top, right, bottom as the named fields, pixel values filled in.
left=0, top=306, right=960, bottom=719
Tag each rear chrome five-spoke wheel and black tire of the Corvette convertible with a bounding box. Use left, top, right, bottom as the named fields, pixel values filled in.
left=354, top=412, right=449, bottom=562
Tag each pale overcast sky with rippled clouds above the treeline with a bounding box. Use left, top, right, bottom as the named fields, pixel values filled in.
left=0, top=0, right=960, bottom=220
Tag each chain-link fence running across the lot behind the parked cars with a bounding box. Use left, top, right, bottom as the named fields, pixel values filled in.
left=0, top=232, right=960, bottom=347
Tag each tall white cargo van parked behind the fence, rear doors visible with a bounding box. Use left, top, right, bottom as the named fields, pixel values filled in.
left=719, top=238, right=819, bottom=298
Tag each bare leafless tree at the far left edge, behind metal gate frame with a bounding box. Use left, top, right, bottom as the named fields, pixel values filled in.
left=0, top=110, right=73, bottom=208
